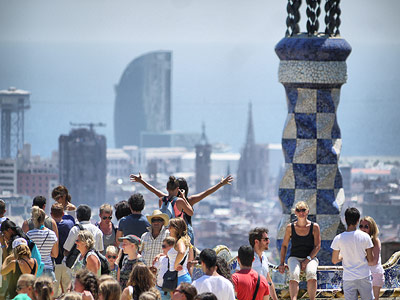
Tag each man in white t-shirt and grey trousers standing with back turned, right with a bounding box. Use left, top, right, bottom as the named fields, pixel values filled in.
left=331, top=207, right=374, bottom=300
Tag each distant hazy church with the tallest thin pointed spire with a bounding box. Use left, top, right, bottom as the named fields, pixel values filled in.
left=237, top=104, right=269, bottom=201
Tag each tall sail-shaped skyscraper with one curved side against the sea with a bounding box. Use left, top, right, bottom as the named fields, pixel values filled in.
left=114, top=51, right=172, bottom=148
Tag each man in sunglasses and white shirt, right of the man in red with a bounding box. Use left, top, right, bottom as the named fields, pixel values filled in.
left=249, top=227, right=278, bottom=300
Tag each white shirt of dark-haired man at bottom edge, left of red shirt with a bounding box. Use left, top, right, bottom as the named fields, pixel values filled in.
left=192, top=275, right=235, bottom=300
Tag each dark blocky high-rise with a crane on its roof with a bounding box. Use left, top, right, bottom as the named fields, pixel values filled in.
left=59, top=127, right=107, bottom=206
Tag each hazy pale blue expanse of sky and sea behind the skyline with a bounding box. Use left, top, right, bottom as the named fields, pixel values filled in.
left=0, top=0, right=400, bottom=155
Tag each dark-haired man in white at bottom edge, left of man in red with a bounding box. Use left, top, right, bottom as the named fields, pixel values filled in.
left=192, top=249, right=235, bottom=300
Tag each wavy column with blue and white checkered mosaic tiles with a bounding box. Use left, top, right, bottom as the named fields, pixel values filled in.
left=275, top=34, right=351, bottom=265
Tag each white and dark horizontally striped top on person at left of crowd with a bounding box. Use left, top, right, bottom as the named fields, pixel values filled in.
left=26, top=228, right=57, bottom=270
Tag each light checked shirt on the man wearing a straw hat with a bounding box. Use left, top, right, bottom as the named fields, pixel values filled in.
left=141, top=226, right=169, bottom=266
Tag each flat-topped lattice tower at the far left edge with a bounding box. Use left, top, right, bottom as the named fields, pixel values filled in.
left=0, top=87, right=30, bottom=158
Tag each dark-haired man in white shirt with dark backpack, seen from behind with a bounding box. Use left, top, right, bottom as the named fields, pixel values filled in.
left=64, top=204, right=104, bottom=256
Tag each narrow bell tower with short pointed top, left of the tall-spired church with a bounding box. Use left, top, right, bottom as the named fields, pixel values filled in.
left=195, top=123, right=211, bottom=193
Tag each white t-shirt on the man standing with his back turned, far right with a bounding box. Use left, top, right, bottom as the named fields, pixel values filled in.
left=331, top=230, right=373, bottom=280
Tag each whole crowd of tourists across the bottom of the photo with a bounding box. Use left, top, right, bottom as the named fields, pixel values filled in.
left=0, top=173, right=384, bottom=300
